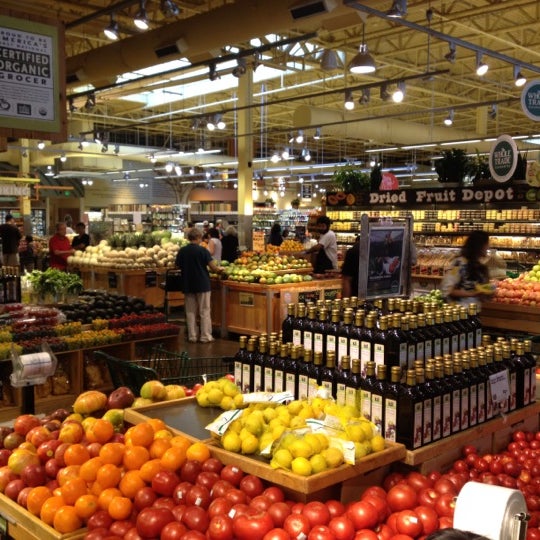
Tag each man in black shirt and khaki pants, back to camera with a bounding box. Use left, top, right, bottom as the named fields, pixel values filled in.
left=176, top=227, right=222, bottom=343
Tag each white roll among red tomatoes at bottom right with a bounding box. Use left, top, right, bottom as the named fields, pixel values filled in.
left=454, top=482, right=527, bottom=540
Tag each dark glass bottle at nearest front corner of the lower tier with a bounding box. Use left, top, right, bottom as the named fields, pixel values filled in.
left=397, top=369, right=424, bottom=450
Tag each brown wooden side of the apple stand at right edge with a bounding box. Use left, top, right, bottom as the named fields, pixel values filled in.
left=480, top=302, right=540, bottom=335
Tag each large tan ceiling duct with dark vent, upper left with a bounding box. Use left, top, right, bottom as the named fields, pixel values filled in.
left=66, top=0, right=351, bottom=87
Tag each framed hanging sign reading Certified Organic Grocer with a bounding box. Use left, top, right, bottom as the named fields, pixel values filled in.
left=0, top=15, right=60, bottom=132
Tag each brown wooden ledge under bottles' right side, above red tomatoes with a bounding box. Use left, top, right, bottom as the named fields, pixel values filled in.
left=403, top=401, right=540, bottom=474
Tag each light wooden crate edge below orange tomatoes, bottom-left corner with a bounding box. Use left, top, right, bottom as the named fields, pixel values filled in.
left=0, top=494, right=87, bottom=540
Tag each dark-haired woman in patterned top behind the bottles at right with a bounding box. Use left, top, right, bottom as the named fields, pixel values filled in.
left=441, top=231, right=493, bottom=305
